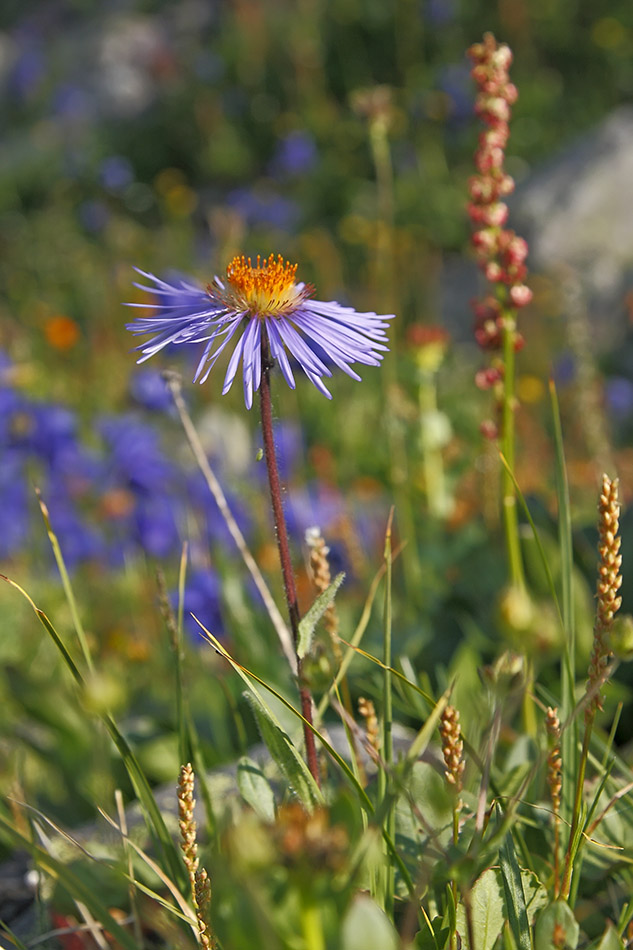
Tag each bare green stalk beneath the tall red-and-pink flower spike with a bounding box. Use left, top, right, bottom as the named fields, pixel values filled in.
left=501, top=310, right=525, bottom=590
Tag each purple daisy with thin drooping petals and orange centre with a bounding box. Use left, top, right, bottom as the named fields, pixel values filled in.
left=127, top=254, right=393, bottom=409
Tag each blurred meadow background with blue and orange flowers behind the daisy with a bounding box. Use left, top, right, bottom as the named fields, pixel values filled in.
left=0, top=0, right=633, bottom=836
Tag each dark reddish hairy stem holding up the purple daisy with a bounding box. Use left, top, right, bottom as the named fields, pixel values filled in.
left=259, top=330, right=321, bottom=787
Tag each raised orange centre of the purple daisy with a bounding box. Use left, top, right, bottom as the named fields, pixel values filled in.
left=226, top=254, right=298, bottom=316
